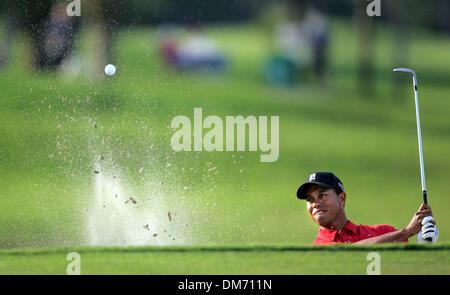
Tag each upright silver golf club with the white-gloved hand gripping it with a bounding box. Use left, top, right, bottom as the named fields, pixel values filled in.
left=394, top=68, right=439, bottom=242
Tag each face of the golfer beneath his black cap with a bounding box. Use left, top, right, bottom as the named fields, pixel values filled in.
left=306, top=185, right=342, bottom=226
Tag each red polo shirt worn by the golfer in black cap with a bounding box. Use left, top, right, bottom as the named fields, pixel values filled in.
left=314, top=220, right=408, bottom=245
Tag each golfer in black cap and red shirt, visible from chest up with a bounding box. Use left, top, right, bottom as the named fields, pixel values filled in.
left=297, top=172, right=434, bottom=244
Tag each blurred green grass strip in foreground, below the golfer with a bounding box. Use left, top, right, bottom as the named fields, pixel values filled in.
left=0, top=244, right=450, bottom=275
